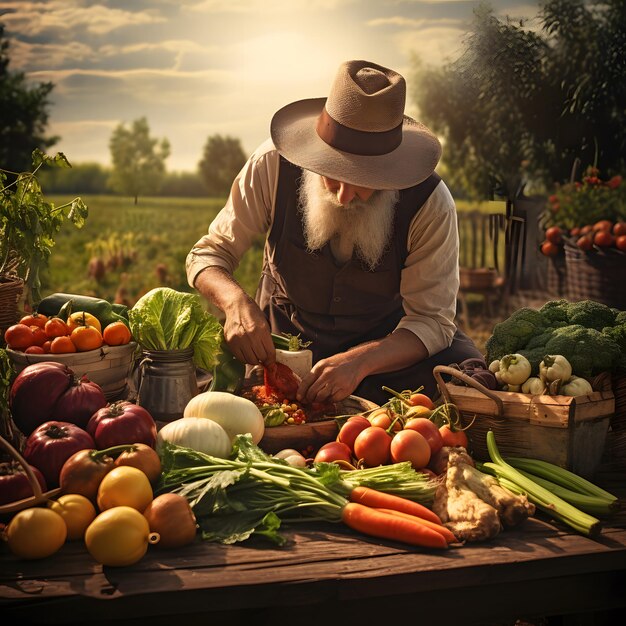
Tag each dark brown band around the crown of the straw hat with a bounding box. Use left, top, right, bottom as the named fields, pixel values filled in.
left=316, top=107, right=402, bottom=156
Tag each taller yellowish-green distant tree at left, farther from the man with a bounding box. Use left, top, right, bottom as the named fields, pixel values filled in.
left=109, top=117, right=170, bottom=204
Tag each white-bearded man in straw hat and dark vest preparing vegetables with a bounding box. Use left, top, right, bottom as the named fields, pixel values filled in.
left=187, top=61, right=481, bottom=403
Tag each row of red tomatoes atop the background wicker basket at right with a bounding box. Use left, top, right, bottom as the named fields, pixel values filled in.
left=541, top=220, right=626, bottom=256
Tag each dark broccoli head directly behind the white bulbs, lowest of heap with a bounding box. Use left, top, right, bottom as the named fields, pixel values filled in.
left=545, top=324, right=621, bottom=378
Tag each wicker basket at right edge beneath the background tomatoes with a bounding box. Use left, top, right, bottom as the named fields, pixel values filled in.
left=565, top=245, right=626, bottom=310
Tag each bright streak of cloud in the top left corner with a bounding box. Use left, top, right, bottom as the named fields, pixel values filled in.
left=2, top=0, right=165, bottom=38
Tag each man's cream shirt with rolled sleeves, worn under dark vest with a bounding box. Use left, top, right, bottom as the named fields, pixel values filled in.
left=186, top=140, right=459, bottom=355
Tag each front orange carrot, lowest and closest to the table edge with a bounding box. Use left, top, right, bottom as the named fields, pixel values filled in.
left=341, top=502, right=448, bottom=548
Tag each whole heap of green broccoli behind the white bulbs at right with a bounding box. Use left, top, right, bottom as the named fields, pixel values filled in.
left=486, top=300, right=626, bottom=379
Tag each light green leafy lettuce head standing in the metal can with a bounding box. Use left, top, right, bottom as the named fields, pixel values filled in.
left=128, top=287, right=222, bottom=371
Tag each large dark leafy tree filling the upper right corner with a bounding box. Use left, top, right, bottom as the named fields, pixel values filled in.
left=412, top=0, right=626, bottom=197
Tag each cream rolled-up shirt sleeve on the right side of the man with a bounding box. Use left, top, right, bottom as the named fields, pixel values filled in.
left=397, top=181, right=459, bottom=355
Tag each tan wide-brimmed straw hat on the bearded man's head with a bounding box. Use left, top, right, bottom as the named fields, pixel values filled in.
left=270, top=61, right=441, bottom=189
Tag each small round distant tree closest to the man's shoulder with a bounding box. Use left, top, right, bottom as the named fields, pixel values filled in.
left=198, top=135, right=246, bottom=196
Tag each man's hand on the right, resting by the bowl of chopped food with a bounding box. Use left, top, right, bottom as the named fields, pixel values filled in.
left=296, top=352, right=364, bottom=404
